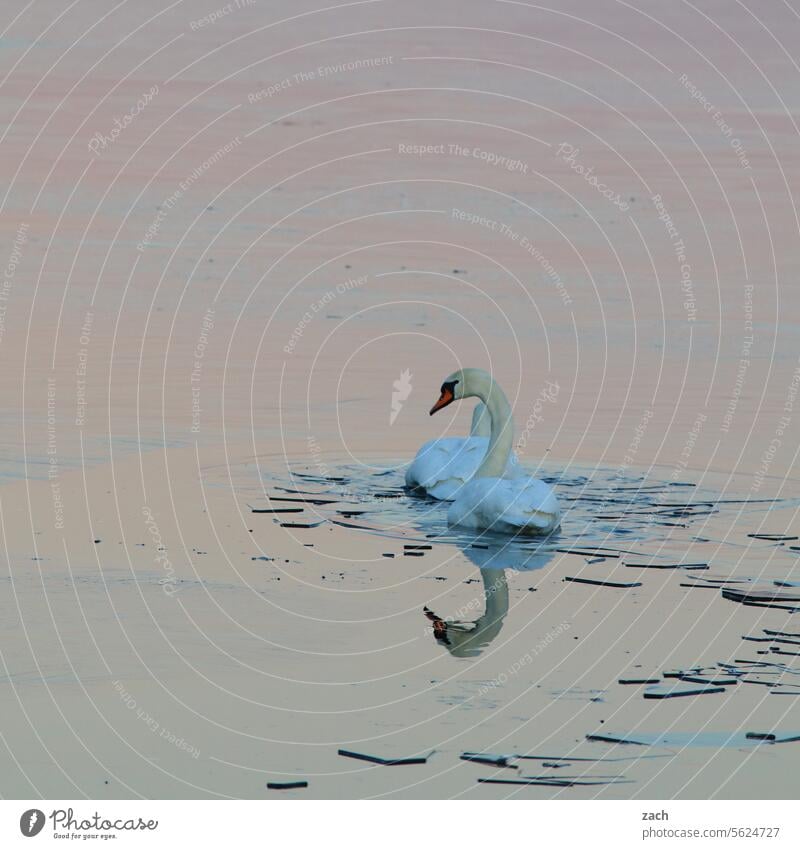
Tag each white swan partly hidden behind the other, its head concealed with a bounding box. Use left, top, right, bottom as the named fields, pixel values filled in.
left=406, top=404, right=519, bottom=501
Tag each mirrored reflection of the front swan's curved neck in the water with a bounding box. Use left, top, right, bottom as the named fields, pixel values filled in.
left=423, top=535, right=553, bottom=657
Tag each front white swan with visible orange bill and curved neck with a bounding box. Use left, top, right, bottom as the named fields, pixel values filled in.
left=431, top=368, right=561, bottom=535
